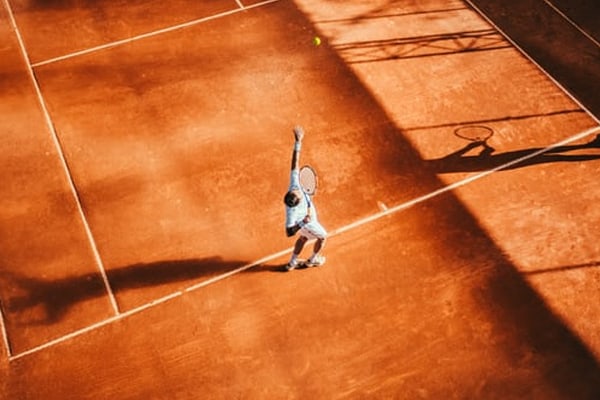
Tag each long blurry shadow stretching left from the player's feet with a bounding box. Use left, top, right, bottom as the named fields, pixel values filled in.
left=1, top=257, right=247, bottom=324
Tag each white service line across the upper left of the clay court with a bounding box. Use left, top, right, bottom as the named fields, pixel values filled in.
left=29, top=0, right=279, bottom=68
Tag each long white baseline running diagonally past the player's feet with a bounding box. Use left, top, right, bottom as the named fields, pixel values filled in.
left=9, top=126, right=600, bottom=361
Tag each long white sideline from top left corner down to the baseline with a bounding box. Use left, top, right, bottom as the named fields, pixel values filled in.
left=4, top=0, right=119, bottom=314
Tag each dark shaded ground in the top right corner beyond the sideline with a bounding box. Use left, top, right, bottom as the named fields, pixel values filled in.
left=472, top=0, right=600, bottom=119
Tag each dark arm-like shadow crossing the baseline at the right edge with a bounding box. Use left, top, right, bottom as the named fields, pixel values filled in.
left=425, top=135, right=600, bottom=173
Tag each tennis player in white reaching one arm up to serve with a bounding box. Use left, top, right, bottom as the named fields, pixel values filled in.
left=283, top=126, right=327, bottom=271
